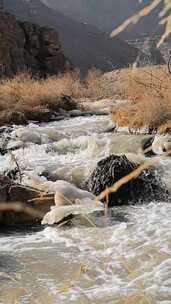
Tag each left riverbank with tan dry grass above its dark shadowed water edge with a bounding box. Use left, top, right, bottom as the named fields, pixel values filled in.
left=0, top=74, right=78, bottom=126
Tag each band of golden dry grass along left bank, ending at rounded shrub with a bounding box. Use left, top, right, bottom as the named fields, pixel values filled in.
left=0, top=70, right=112, bottom=111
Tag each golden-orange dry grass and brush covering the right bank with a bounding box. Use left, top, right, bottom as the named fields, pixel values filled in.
left=113, top=67, right=171, bottom=131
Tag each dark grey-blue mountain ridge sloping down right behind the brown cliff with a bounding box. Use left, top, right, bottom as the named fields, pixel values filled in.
left=4, top=0, right=137, bottom=72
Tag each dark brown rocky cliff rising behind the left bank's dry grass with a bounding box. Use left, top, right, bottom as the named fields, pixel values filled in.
left=0, top=11, right=69, bottom=76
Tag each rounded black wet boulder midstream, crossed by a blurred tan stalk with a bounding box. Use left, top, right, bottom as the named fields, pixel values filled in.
left=86, top=155, right=167, bottom=207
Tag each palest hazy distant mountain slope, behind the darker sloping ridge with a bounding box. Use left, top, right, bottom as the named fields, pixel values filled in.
left=41, top=0, right=161, bottom=39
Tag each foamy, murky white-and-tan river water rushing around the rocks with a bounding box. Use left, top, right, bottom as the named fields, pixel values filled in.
left=0, top=116, right=171, bottom=304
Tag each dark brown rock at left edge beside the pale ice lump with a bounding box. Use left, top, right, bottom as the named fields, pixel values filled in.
left=0, top=175, right=54, bottom=226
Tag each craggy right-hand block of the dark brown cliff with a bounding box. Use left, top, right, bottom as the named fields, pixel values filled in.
left=19, top=22, right=70, bottom=76
